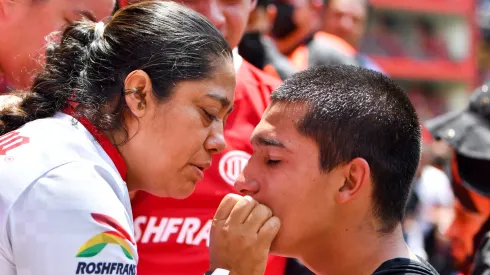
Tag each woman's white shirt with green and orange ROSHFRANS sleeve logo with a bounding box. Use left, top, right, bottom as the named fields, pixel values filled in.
left=0, top=114, right=138, bottom=275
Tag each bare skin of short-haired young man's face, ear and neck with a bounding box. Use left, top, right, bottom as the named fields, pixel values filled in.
left=235, top=102, right=415, bottom=274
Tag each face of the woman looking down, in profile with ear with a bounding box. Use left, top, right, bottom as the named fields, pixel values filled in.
left=119, top=58, right=235, bottom=198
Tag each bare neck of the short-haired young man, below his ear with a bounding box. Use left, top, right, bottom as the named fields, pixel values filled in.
left=299, top=226, right=416, bottom=275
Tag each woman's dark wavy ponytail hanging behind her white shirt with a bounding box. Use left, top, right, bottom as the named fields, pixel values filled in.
left=0, top=16, right=101, bottom=136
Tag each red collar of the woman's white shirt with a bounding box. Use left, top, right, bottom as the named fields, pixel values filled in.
left=63, top=106, right=126, bottom=181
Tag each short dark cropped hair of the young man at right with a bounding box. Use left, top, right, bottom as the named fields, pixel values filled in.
left=272, top=65, right=421, bottom=232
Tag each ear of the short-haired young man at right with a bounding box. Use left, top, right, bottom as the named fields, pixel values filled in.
left=337, top=158, right=371, bottom=203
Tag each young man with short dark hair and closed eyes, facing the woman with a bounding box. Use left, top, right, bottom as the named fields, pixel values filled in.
left=224, top=65, right=437, bottom=275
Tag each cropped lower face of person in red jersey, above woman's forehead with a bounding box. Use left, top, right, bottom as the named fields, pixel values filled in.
left=174, top=0, right=257, bottom=48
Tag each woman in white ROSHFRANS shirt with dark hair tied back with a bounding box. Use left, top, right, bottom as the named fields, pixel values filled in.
left=0, top=2, right=278, bottom=275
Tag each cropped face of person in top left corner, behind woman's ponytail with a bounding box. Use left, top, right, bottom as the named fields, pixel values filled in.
left=0, top=0, right=115, bottom=94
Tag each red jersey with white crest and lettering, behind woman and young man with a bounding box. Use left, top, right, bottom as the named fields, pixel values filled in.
left=132, top=57, right=286, bottom=275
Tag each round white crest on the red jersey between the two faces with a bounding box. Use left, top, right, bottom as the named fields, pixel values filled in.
left=219, top=150, right=250, bottom=186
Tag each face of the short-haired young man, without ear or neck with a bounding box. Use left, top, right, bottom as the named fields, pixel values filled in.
left=235, top=103, right=344, bottom=256
